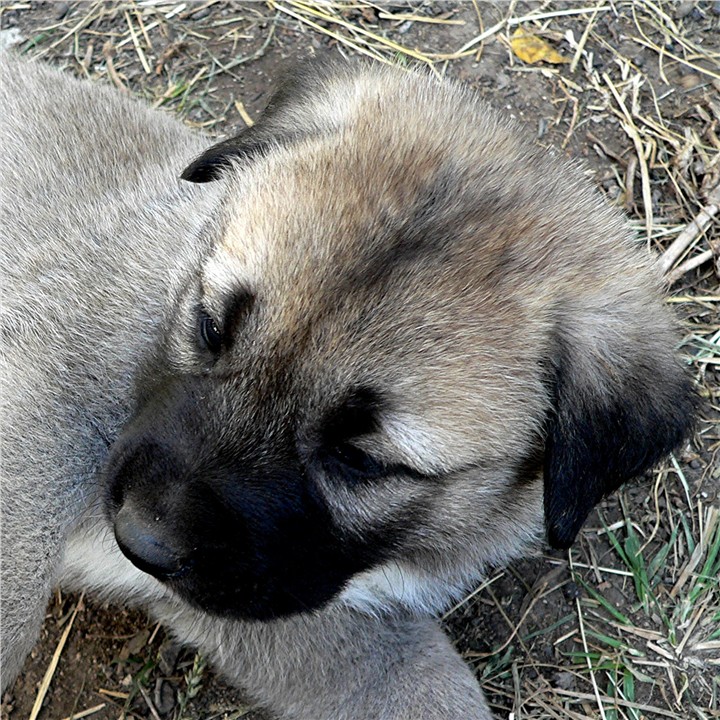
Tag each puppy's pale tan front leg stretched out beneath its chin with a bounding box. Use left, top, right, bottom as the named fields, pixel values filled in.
left=158, top=607, right=492, bottom=720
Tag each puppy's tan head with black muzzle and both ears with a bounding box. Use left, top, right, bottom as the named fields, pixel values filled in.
left=108, top=60, right=692, bottom=619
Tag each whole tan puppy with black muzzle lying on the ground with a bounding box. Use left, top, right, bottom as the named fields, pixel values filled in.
left=0, top=57, right=693, bottom=720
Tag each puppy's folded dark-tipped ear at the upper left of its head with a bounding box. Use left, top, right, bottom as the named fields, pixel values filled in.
left=180, top=55, right=351, bottom=183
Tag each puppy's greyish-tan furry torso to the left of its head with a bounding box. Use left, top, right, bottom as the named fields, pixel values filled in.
left=0, top=56, right=213, bottom=685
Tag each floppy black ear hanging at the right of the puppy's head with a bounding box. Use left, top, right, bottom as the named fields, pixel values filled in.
left=544, top=331, right=696, bottom=548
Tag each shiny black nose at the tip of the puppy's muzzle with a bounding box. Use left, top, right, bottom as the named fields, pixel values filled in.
left=115, top=502, right=189, bottom=580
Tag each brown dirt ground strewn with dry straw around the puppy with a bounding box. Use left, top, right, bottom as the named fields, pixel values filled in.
left=0, top=0, right=720, bottom=720
